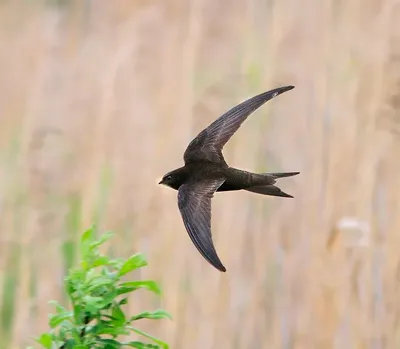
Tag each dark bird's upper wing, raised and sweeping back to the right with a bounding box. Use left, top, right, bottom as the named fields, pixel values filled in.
left=183, top=86, right=294, bottom=164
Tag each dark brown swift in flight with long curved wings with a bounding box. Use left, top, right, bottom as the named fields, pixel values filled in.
left=158, top=86, right=300, bottom=272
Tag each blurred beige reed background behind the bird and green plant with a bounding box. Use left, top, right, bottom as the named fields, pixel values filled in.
left=0, top=0, right=400, bottom=349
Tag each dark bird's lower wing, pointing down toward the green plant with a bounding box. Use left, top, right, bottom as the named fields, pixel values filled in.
left=178, top=179, right=226, bottom=271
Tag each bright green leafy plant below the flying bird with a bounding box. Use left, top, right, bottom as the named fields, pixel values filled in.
left=29, top=228, right=171, bottom=349
